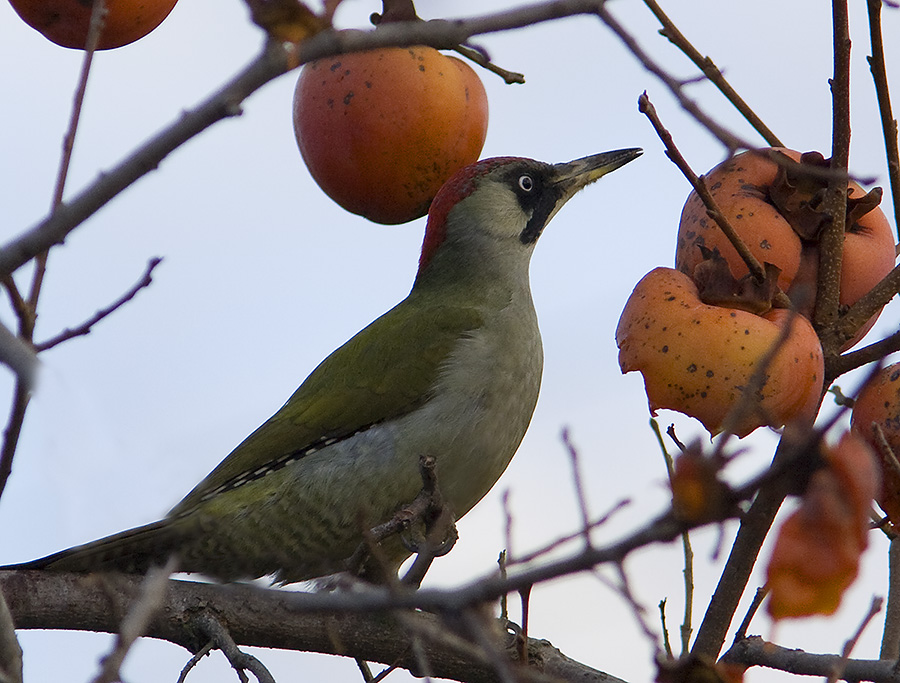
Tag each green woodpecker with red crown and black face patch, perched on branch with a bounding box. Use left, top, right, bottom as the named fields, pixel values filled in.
left=5, top=149, right=641, bottom=583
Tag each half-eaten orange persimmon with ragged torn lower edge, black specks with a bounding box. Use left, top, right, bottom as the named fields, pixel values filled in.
left=616, top=268, right=824, bottom=436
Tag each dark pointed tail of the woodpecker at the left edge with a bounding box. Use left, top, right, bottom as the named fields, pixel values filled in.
left=0, top=520, right=181, bottom=574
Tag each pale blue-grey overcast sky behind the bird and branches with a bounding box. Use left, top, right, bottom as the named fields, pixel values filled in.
left=0, top=0, right=900, bottom=683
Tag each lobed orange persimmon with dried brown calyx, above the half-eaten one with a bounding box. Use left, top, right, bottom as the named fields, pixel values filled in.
left=675, top=148, right=895, bottom=345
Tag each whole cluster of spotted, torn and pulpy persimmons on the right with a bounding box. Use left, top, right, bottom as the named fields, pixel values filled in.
left=616, top=149, right=900, bottom=618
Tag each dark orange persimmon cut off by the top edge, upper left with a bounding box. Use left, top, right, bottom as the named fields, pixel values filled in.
left=9, top=0, right=178, bottom=50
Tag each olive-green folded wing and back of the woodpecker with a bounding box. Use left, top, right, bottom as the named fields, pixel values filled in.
left=169, top=294, right=483, bottom=515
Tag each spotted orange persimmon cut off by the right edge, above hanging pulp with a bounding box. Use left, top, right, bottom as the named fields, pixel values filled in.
left=850, top=363, right=900, bottom=524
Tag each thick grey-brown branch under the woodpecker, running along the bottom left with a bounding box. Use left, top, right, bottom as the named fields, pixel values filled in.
left=0, top=571, right=623, bottom=683
